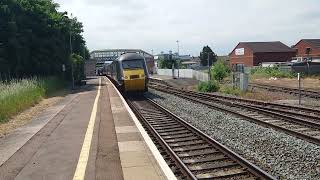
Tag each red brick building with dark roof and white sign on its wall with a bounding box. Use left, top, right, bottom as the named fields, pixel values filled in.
left=229, top=41, right=296, bottom=67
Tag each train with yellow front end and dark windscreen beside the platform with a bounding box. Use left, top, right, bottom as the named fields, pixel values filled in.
left=106, top=53, right=149, bottom=93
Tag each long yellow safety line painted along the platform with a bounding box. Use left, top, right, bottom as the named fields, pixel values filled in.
left=73, top=78, right=101, bottom=180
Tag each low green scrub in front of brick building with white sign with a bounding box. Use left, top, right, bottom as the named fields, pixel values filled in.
left=250, top=67, right=296, bottom=78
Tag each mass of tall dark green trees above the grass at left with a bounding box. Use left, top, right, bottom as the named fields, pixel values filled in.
left=0, top=0, right=89, bottom=80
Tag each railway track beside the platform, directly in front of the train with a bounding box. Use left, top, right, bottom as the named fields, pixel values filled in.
left=127, top=97, right=275, bottom=179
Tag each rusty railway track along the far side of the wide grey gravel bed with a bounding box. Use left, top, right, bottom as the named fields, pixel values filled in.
left=150, top=79, right=320, bottom=145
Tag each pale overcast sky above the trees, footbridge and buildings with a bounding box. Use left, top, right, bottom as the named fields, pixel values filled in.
left=54, top=0, right=320, bottom=56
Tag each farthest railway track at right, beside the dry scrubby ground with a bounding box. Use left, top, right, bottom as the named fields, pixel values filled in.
left=249, top=83, right=320, bottom=99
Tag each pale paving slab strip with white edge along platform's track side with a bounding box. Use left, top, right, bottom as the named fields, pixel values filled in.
left=108, top=76, right=176, bottom=180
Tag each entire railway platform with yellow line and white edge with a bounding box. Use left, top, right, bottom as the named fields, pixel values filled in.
left=0, top=77, right=175, bottom=180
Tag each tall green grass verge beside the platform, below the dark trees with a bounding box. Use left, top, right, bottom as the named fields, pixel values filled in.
left=0, top=77, right=67, bottom=123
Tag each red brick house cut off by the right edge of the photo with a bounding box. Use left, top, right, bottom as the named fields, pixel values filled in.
left=293, top=39, right=320, bottom=61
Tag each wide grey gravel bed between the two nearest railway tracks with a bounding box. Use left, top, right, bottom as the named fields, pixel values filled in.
left=146, top=90, right=320, bottom=180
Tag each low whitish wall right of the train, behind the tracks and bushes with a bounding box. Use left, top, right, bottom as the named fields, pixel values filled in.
left=157, top=69, right=208, bottom=81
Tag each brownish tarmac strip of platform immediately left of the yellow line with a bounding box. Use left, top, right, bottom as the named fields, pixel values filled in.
left=15, top=87, right=96, bottom=180
